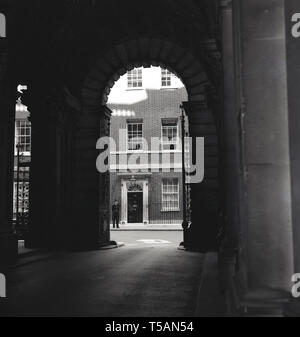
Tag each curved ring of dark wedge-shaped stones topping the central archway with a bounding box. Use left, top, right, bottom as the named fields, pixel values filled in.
left=81, top=37, right=209, bottom=106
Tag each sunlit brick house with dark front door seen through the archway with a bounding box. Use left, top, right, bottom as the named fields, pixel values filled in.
left=108, top=67, right=187, bottom=224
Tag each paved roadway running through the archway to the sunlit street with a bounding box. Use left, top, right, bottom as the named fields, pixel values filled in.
left=0, top=231, right=216, bottom=317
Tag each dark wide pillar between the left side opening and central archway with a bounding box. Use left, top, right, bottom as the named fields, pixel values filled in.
left=26, top=86, right=71, bottom=249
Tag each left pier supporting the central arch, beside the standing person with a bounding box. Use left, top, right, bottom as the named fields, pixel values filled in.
left=70, top=106, right=110, bottom=250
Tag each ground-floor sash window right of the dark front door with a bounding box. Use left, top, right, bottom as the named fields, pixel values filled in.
left=162, top=178, right=179, bottom=212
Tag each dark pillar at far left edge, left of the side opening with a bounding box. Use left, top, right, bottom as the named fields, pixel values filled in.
left=0, top=52, right=18, bottom=271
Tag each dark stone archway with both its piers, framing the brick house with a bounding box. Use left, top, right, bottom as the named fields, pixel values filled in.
left=68, top=38, right=219, bottom=250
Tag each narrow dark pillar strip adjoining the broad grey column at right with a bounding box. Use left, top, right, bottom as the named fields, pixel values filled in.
left=219, top=0, right=241, bottom=287
